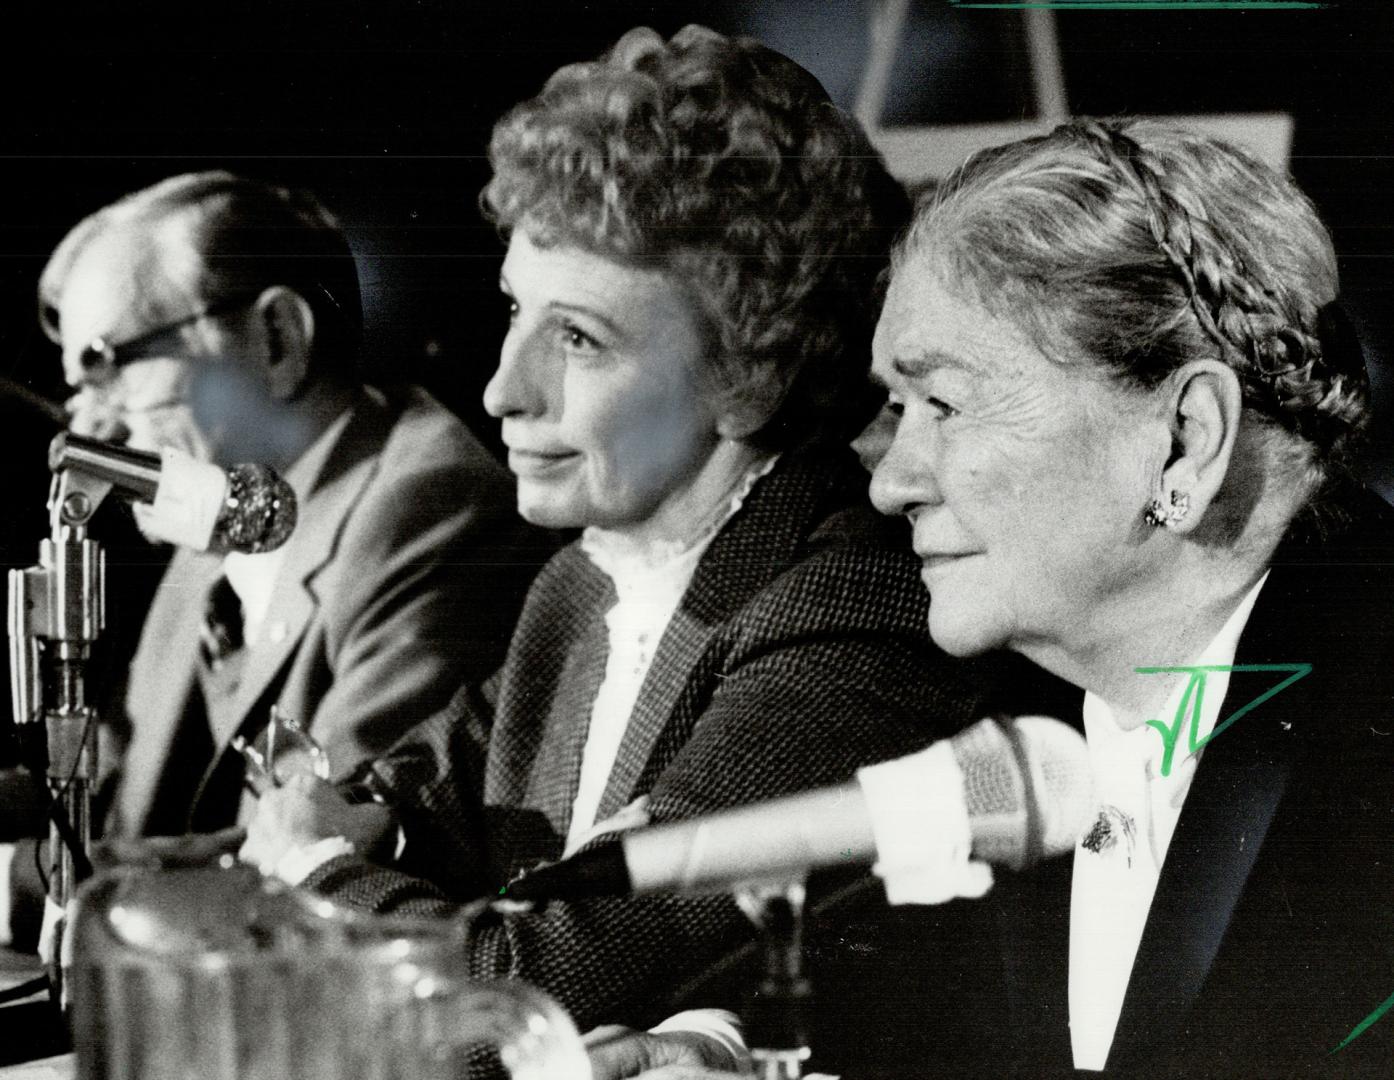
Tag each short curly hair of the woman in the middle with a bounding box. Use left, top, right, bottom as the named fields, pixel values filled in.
left=481, top=26, right=909, bottom=447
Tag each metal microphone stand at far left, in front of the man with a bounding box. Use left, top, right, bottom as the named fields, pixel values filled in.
left=8, top=468, right=112, bottom=1009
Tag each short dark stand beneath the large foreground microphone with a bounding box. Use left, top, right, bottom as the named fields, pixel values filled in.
left=736, top=879, right=813, bottom=1080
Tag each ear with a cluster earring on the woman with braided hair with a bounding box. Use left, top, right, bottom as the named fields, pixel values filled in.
left=1153, top=360, right=1243, bottom=532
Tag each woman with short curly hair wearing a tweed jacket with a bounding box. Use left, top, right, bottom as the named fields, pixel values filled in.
left=245, top=26, right=1031, bottom=1053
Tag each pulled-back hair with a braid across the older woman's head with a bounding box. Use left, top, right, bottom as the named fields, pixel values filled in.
left=896, top=120, right=1370, bottom=489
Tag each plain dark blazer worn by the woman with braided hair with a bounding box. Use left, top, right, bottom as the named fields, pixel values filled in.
left=815, top=496, right=1394, bottom=1080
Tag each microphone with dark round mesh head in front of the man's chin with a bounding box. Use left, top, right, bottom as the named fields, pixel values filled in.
left=49, top=432, right=296, bottom=555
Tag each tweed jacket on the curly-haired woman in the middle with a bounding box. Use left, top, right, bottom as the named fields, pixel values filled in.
left=307, top=447, right=1003, bottom=1030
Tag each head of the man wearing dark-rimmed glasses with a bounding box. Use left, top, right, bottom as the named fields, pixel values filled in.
left=39, top=173, right=362, bottom=465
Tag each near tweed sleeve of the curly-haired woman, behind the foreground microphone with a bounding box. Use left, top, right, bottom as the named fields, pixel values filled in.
left=451, top=549, right=977, bottom=1028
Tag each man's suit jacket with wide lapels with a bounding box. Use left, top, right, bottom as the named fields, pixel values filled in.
left=106, top=389, right=551, bottom=833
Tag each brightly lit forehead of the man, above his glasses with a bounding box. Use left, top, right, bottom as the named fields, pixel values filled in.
left=50, top=220, right=198, bottom=347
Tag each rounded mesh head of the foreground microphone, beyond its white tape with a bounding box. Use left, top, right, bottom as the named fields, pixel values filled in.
left=949, top=716, right=1094, bottom=870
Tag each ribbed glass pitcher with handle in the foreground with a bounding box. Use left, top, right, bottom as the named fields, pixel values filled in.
left=70, top=857, right=591, bottom=1080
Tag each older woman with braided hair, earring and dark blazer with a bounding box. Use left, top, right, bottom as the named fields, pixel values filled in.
left=606, top=121, right=1394, bottom=1080
